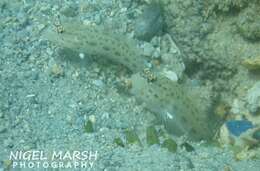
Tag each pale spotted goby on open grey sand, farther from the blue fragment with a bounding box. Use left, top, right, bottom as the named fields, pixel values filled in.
left=43, top=22, right=145, bottom=72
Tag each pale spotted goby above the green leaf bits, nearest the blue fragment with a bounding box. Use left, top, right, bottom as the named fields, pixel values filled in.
left=131, top=74, right=219, bottom=140
